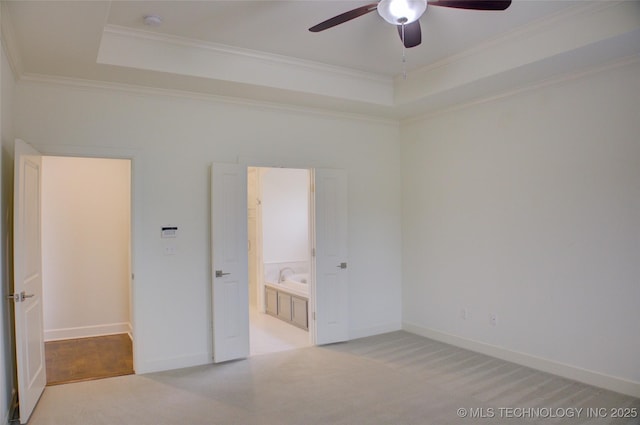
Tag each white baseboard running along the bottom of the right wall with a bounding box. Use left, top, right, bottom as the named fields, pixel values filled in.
left=402, top=322, right=640, bottom=398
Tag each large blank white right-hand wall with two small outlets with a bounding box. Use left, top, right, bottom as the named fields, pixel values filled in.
left=401, top=61, right=640, bottom=395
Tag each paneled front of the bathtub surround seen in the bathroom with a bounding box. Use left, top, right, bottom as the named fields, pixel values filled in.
left=264, top=284, right=309, bottom=330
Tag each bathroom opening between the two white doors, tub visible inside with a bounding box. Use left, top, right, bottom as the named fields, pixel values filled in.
left=247, top=167, right=313, bottom=356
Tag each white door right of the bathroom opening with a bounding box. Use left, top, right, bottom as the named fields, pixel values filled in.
left=312, top=169, right=349, bottom=345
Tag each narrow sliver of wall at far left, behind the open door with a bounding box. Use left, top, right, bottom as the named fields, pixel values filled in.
left=0, top=29, right=16, bottom=423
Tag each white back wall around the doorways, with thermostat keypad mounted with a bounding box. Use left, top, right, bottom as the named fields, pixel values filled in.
left=15, top=81, right=401, bottom=372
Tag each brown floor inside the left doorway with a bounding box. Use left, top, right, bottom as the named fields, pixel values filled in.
left=45, top=334, right=133, bottom=385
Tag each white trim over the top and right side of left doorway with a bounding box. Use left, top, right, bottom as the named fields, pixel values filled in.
left=34, top=145, right=142, bottom=373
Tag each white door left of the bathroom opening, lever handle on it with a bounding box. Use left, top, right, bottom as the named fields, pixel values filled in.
left=211, top=164, right=249, bottom=363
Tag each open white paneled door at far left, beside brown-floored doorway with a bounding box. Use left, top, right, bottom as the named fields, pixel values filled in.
left=13, top=140, right=47, bottom=424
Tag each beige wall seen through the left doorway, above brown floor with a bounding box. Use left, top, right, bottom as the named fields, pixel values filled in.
left=42, top=156, right=131, bottom=340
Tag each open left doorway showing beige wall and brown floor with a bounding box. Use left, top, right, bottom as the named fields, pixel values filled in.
left=42, top=156, right=134, bottom=385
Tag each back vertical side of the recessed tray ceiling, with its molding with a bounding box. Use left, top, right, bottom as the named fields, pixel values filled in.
left=97, top=25, right=393, bottom=106
